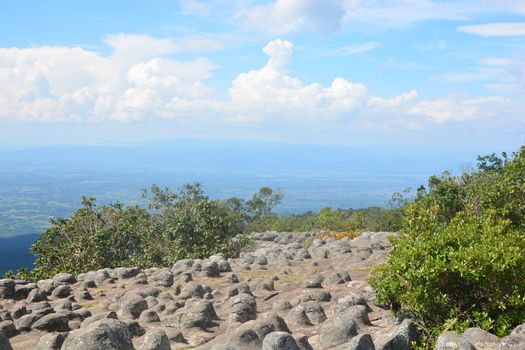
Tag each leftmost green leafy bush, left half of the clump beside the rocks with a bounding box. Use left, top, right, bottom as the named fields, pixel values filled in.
left=30, top=198, right=149, bottom=279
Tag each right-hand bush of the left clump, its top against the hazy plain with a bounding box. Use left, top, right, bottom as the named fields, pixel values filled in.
left=132, top=183, right=241, bottom=266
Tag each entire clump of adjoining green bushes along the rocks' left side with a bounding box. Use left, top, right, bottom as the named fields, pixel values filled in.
left=7, top=183, right=250, bottom=280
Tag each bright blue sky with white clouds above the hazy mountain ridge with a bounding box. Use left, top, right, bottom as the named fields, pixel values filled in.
left=0, top=0, right=525, bottom=150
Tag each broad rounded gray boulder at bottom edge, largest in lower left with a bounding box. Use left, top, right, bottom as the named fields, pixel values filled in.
left=62, top=318, right=133, bottom=350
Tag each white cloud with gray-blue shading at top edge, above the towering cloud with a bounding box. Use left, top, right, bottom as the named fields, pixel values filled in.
left=236, top=0, right=345, bottom=34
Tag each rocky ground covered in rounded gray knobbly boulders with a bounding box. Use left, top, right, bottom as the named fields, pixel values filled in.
left=0, top=232, right=525, bottom=350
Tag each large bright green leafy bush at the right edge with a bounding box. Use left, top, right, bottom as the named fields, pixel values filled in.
left=370, top=147, right=525, bottom=344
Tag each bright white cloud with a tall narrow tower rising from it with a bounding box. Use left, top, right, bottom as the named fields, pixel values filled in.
left=229, top=39, right=367, bottom=120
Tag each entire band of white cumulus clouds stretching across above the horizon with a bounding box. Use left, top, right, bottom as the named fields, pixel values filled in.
left=0, top=35, right=508, bottom=129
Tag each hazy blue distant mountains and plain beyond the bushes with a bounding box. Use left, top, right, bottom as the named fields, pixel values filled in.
left=0, top=140, right=484, bottom=236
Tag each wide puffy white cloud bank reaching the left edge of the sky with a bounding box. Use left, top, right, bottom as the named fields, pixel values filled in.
left=0, top=35, right=214, bottom=121
